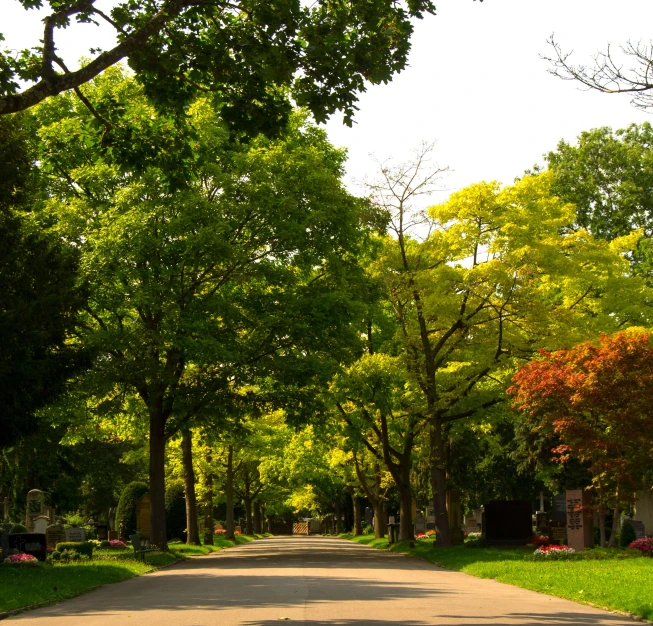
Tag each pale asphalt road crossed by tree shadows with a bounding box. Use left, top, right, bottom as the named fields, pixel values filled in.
left=5, top=537, right=633, bottom=626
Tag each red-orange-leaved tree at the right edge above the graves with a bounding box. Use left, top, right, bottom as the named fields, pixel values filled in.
left=508, top=329, right=653, bottom=546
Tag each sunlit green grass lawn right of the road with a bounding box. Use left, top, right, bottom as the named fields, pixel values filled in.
left=341, top=535, right=653, bottom=620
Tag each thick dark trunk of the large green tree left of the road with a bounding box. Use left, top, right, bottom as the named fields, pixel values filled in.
left=150, top=411, right=168, bottom=550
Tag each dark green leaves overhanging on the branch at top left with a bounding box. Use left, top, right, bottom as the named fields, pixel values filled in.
left=0, top=0, right=435, bottom=130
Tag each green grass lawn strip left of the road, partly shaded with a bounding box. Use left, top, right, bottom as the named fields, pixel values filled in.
left=0, top=535, right=255, bottom=611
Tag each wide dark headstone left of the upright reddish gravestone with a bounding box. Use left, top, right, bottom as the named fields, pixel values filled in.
left=483, top=500, right=533, bottom=546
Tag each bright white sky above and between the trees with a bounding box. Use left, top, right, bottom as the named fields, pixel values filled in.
left=0, top=0, right=653, bottom=200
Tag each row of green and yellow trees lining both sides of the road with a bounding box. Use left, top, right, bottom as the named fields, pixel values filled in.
left=0, top=53, right=651, bottom=546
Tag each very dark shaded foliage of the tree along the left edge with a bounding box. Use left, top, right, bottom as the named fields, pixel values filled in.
left=0, top=116, right=88, bottom=448
